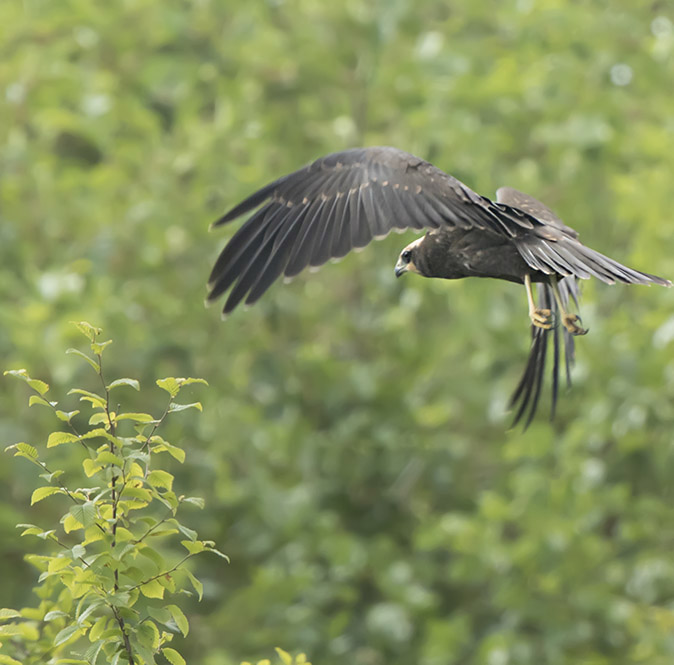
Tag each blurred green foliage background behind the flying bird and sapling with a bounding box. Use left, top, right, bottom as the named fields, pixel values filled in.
left=0, top=0, right=674, bottom=665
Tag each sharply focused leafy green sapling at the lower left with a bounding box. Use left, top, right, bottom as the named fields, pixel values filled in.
left=0, top=323, right=220, bottom=665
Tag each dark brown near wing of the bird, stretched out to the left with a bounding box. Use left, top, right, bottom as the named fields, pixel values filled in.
left=208, top=147, right=541, bottom=314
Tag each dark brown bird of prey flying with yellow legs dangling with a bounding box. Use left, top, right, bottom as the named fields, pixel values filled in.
left=208, top=147, right=671, bottom=427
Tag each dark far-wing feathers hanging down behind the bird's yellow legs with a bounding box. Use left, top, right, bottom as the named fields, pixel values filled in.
left=510, top=276, right=578, bottom=429
